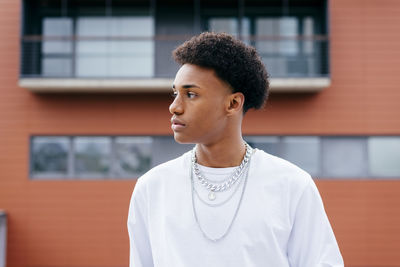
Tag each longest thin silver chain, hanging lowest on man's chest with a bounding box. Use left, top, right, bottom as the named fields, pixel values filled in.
left=190, top=149, right=251, bottom=242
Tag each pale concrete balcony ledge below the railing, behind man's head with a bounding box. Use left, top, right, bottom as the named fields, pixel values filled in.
left=18, top=78, right=331, bottom=93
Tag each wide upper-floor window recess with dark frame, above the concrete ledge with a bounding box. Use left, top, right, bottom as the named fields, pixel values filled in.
left=21, top=0, right=329, bottom=78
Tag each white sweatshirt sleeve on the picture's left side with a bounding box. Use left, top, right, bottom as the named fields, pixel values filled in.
left=127, top=178, right=154, bottom=267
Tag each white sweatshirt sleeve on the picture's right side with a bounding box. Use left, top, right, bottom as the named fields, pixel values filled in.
left=288, top=178, right=344, bottom=267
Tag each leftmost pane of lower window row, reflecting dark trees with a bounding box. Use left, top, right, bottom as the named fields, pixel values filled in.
left=31, top=137, right=69, bottom=176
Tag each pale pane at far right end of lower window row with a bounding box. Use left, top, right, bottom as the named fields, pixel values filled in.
left=368, top=137, right=400, bottom=177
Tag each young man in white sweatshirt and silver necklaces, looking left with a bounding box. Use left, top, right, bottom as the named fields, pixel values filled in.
left=128, top=33, right=343, bottom=267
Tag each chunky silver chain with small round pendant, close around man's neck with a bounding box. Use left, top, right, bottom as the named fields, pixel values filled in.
left=192, top=142, right=252, bottom=201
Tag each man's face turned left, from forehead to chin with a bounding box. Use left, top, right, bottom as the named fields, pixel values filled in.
left=169, top=64, right=232, bottom=144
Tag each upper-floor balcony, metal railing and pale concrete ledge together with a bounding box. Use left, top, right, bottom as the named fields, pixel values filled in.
left=19, top=35, right=330, bottom=92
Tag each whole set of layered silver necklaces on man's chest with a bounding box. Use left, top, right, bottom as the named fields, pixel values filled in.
left=190, top=143, right=253, bottom=242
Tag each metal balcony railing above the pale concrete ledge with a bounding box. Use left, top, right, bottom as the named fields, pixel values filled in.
left=20, top=35, right=329, bottom=79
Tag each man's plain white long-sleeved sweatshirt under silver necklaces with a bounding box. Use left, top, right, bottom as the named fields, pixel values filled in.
left=128, top=149, right=344, bottom=267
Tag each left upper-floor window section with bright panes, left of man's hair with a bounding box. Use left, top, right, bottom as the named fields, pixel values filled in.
left=21, top=0, right=155, bottom=78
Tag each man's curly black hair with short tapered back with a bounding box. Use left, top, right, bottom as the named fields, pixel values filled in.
left=172, top=32, right=269, bottom=113
